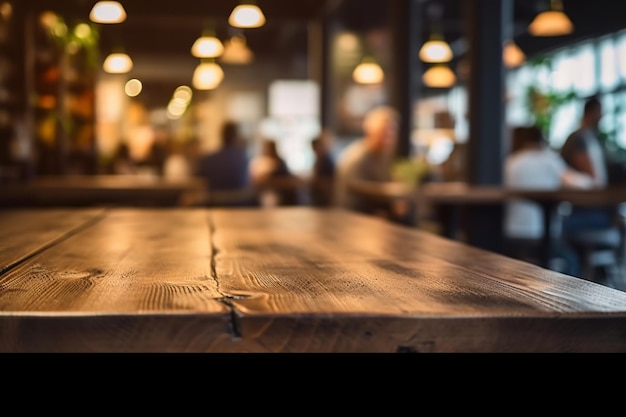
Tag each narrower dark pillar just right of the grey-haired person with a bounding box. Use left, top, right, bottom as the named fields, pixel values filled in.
left=389, top=0, right=422, bottom=157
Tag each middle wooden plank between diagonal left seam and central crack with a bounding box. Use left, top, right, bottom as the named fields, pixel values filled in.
left=0, top=209, right=232, bottom=351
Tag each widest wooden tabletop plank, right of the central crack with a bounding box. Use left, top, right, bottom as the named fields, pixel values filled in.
left=207, top=209, right=626, bottom=352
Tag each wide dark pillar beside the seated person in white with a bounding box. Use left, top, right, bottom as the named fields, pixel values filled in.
left=464, top=0, right=513, bottom=251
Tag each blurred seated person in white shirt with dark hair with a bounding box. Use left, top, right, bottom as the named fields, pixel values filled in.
left=504, top=126, right=593, bottom=275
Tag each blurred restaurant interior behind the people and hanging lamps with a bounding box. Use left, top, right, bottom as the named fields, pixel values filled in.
left=0, top=0, right=626, bottom=183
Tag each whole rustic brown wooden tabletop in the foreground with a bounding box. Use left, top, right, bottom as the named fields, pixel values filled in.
left=0, top=207, right=626, bottom=352
